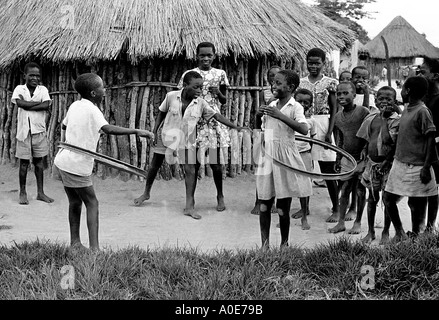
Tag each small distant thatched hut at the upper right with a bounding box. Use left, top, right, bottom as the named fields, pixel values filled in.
left=363, top=16, right=439, bottom=79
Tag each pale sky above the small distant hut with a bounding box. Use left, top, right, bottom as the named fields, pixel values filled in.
left=302, top=0, right=439, bottom=47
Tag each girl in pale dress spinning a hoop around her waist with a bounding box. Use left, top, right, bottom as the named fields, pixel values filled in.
left=256, top=70, right=312, bottom=248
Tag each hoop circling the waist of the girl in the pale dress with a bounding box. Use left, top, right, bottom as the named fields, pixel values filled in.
left=264, top=135, right=357, bottom=180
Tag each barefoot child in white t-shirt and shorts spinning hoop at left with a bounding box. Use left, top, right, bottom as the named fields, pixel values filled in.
left=54, top=73, right=153, bottom=250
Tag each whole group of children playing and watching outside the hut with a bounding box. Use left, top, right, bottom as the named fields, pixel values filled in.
left=12, top=42, right=439, bottom=249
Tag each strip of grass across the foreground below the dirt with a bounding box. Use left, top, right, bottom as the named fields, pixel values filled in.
left=0, top=234, right=439, bottom=300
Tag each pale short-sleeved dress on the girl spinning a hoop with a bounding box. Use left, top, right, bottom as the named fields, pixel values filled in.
left=256, top=98, right=312, bottom=200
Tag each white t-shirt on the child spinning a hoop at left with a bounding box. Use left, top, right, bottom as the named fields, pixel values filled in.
left=54, top=99, right=108, bottom=176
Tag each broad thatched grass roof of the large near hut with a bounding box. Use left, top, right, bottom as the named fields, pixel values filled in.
left=0, top=0, right=354, bottom=68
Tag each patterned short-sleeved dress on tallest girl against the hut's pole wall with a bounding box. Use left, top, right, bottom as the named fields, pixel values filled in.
left=178, top=68, right=230, bottom=154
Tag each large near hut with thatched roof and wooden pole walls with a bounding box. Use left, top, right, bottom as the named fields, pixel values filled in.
left=0, top=0, right=353, bottom=179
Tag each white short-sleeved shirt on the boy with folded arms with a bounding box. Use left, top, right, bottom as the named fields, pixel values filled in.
left=11, top=84, right=52, bottom=141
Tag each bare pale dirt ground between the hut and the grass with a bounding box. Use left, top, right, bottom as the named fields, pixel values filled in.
left=0, top=164, right=411, bottom=252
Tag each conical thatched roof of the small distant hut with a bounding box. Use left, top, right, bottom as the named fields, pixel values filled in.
left=363, top=16, right=439, bottom=59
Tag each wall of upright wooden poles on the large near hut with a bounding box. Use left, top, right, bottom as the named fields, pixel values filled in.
left=0, top=56, right=295, bottom=181
